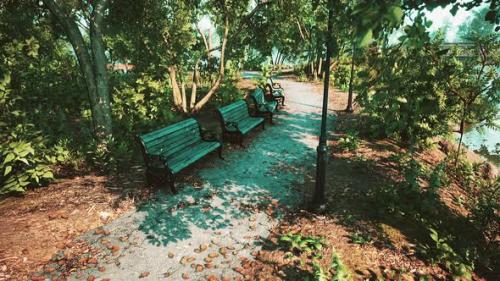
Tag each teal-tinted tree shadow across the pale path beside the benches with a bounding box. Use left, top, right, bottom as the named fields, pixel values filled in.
left=139, top=109, right=320, bottom=246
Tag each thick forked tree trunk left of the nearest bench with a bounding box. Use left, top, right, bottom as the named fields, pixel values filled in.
left=43, top=0, right=112, bottom=141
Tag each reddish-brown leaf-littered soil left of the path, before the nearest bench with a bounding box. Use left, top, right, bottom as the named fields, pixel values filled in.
left=0, top=167, right=154, bottom=280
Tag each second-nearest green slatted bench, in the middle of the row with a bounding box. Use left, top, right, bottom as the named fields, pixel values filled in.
left=217, top=100, right=265, bottom=146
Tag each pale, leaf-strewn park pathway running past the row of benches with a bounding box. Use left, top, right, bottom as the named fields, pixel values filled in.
left=65, top=77, right=332, bottom=280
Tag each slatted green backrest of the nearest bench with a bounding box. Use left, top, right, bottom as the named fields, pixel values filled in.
left=139, top=118, right=201, bottom=157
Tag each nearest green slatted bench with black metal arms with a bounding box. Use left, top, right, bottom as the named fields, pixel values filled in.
left=138, top=118, right=222, bottom=193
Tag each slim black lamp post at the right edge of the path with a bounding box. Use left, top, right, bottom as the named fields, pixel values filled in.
left=313, top=0, right=334, bottom=206
